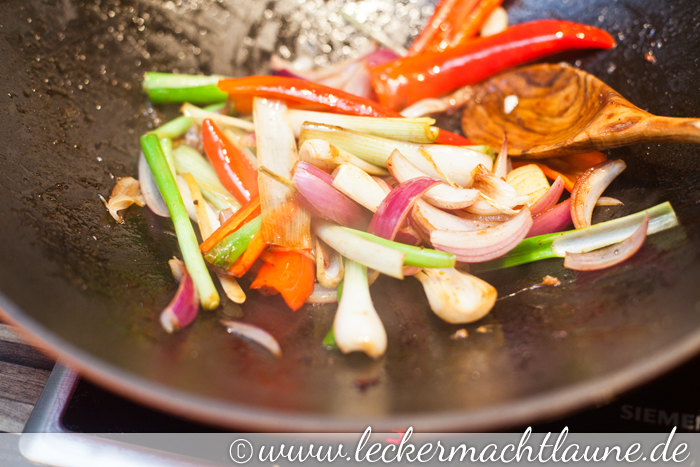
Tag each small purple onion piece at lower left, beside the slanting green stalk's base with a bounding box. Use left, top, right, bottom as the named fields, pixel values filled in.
left=160, top=259, right=199, bottom=333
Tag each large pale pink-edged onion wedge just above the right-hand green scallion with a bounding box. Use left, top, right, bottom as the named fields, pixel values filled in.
left=430, top=207, right=532, bottom=263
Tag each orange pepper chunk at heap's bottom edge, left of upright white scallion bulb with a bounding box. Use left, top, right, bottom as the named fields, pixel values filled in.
left=250, top=250, right=316, bottom=311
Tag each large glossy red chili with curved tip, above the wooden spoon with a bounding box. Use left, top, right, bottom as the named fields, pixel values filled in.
left=370, top=20, right=615, bottom=109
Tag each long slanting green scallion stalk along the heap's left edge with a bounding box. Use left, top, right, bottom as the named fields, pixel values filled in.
left=141, top=134, right=219, bottom=310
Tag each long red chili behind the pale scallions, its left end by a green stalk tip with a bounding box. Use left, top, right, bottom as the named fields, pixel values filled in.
left=218, top=76, right=474, bottom=146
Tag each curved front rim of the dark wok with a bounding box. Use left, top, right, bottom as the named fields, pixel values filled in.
left=0, top=292, right=700, bottom=433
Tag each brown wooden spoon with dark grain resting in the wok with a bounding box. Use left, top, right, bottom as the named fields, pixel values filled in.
left=462, top=64, right=700, bottom=159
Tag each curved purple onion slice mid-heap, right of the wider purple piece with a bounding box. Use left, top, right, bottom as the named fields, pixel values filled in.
left=367, top=177, right=440, bottom=240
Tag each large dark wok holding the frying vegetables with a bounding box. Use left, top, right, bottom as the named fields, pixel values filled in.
left=0, top=0, right=700, bottom=431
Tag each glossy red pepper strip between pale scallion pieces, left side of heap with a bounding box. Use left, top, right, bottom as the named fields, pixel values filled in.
left=202, top=118, right=258, bottom=204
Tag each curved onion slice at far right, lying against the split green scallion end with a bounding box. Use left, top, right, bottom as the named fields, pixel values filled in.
left=564, top=213, right=649, bottom=271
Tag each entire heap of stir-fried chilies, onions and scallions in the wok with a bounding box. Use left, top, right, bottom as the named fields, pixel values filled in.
left=106, top=5, right=678, bottom=358
